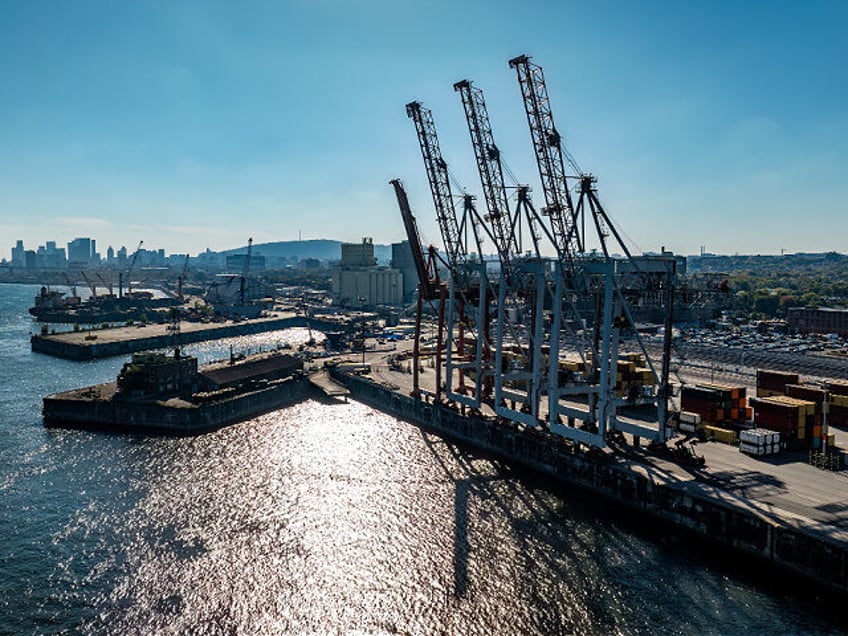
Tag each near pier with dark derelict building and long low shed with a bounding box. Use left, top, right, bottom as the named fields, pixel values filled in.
left=42, top=349, right=311, bottom=435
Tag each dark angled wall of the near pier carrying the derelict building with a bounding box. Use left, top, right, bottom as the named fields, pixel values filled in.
left=42, top=377, right=312, bottom=435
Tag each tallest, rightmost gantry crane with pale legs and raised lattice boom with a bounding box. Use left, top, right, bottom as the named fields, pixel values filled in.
left=509, top=55, right=670, bottom=446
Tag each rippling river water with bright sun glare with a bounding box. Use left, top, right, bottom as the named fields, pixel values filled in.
left=0, top=285, right=846, bottom=635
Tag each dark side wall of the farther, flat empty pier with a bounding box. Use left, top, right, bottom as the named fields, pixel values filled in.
left=30, top=316, right=330, bottom=360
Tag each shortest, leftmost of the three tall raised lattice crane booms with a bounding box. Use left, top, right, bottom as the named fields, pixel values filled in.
left=406, top=102, right=467, bottom=269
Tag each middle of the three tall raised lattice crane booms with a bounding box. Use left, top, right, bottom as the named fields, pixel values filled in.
left=453, top=80, right=521, bottom=269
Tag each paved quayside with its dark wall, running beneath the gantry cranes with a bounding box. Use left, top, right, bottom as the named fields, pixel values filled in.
left=330, top=342, right=848, bottom=594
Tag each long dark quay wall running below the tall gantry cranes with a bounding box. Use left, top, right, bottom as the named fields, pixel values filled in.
left=329, top=367, right=848, bottom=593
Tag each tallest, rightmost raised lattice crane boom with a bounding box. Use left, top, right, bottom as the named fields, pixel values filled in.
left=509, top=55, right=583, bottom=263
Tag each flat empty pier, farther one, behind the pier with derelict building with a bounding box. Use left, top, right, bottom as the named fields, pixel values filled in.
left=30, top=313, right=312, bottom=360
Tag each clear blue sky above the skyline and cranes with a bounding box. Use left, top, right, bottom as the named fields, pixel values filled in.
left=0, top=0, right=848, bottom=258
